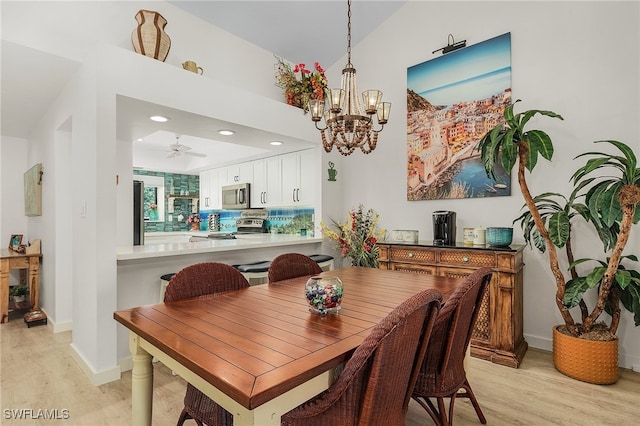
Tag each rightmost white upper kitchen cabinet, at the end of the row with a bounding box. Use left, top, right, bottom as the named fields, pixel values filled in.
left=280, top=149, right=318, bottom=206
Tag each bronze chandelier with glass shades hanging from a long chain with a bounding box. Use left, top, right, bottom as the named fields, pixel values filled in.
left=309, top=0, right=391, bottom=156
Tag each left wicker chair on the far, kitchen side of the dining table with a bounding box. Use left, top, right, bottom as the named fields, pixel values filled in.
left=164, top=262, right=249, bottom=426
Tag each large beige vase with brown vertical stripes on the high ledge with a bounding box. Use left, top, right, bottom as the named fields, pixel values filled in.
left=131, top=9, right=171, bottom=62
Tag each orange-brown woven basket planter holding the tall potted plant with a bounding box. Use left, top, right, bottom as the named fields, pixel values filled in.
left=553, top=325, right=618, bottom=385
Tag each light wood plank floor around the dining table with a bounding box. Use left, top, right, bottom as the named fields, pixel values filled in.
left=0, top=318, right=640, bottom=426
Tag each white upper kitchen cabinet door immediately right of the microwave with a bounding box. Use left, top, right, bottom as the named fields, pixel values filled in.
left=251, top=157, right=282, bottom=207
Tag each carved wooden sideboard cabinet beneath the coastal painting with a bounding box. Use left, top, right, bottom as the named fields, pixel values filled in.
left=378, top=242, right=528, bottom=368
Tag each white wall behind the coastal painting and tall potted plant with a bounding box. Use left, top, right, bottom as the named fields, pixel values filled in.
left=338, top=2, right=640, bottom=367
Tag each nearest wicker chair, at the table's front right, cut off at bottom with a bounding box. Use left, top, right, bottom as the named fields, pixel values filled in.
left=281, top=289, right=442, bottom=426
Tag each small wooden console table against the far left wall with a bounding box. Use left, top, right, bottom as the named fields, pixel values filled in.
left=0, top=249, right=42, bottom=323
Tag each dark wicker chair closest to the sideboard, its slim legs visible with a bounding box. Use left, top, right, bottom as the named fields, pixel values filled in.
left=411, top=268, right=491, bottom=426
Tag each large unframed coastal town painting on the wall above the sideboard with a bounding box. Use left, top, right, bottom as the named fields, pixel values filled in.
left=407, top=33, right=511, bottom=201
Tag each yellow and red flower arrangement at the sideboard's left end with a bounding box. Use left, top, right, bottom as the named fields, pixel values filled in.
left=320, top=204, right=385, bottom=268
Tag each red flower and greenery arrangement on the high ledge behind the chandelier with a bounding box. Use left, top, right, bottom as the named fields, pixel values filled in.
left=276, top=56, right=328, bottom=113
